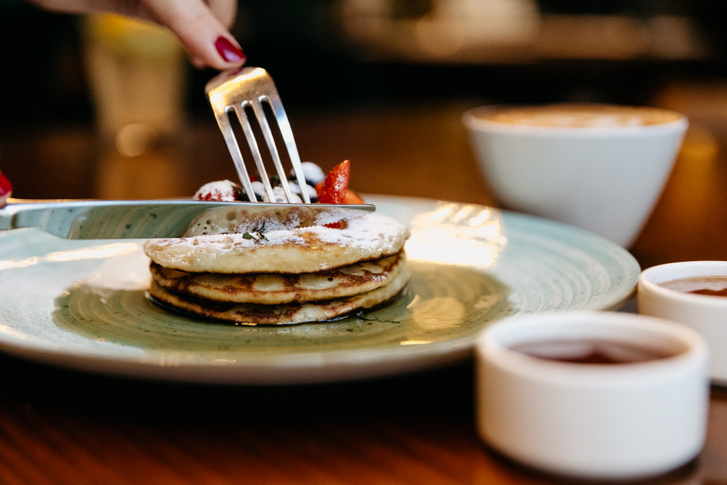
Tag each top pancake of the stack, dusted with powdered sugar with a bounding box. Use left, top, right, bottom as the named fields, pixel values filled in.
left=144, top=213, right=409, bottom=274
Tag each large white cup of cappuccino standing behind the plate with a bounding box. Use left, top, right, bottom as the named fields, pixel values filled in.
left=463, top=105, right=688, bottom=247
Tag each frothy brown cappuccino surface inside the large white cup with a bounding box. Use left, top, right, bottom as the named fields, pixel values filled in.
left=477, top=104, right=682, bottom=128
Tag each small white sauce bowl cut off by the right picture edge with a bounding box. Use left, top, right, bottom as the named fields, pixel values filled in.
left=637, top=261, right=727, bottom=385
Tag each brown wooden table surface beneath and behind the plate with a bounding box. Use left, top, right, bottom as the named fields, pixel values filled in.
left=0, top=102, right=727, bottom=484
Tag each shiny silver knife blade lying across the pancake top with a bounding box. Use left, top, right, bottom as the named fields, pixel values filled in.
left=0, top=198, right=375, bottom=239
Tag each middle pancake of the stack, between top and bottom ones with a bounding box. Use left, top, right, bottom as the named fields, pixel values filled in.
left=150, top=251, right=406, bottom=305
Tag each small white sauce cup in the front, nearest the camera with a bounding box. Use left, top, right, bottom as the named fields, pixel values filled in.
left=475, top=312, right=709, bottom=479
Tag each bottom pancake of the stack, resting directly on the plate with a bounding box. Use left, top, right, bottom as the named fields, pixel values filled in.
left=148, top=269, right=410, bottom=325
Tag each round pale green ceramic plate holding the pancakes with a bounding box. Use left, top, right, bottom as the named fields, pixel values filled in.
left=0, top=196, right=640, bottom=384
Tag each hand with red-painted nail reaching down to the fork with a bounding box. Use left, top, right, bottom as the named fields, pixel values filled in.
left=29, top=0, right=246, bottom=70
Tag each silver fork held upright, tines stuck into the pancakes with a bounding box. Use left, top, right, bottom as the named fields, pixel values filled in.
left=205, top=67, right=310, bottom=204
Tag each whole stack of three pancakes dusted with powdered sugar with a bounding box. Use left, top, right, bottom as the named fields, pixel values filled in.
left=144, top=214, right=410, bottom=325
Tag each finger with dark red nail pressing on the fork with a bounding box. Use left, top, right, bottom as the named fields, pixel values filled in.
left=145, top=0, right=246, bottom=69
